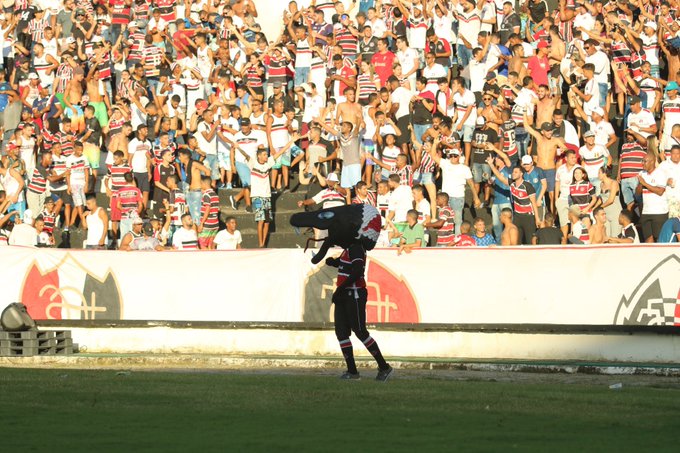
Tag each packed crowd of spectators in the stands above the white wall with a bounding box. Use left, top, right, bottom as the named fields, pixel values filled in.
left=0, top=0, right=680, bottom=249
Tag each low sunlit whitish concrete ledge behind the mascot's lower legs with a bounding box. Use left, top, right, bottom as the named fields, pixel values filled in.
left=14, top=326, right=680, bottom=364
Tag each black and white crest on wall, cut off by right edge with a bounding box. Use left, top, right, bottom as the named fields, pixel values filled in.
left=614, top=255, right=680, bottom=326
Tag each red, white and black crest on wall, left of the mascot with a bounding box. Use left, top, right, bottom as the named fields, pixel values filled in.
left=19, top=254, right=123, bottom=320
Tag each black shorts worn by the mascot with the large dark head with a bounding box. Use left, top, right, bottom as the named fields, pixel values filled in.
left=335, top=288, right=369, bottom=341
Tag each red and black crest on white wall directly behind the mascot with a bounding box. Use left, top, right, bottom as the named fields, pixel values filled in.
left=303, top=258, right=420, bottom=324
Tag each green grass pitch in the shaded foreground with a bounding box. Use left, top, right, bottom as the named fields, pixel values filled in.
left=0, top=369, right=680, bottom=452
